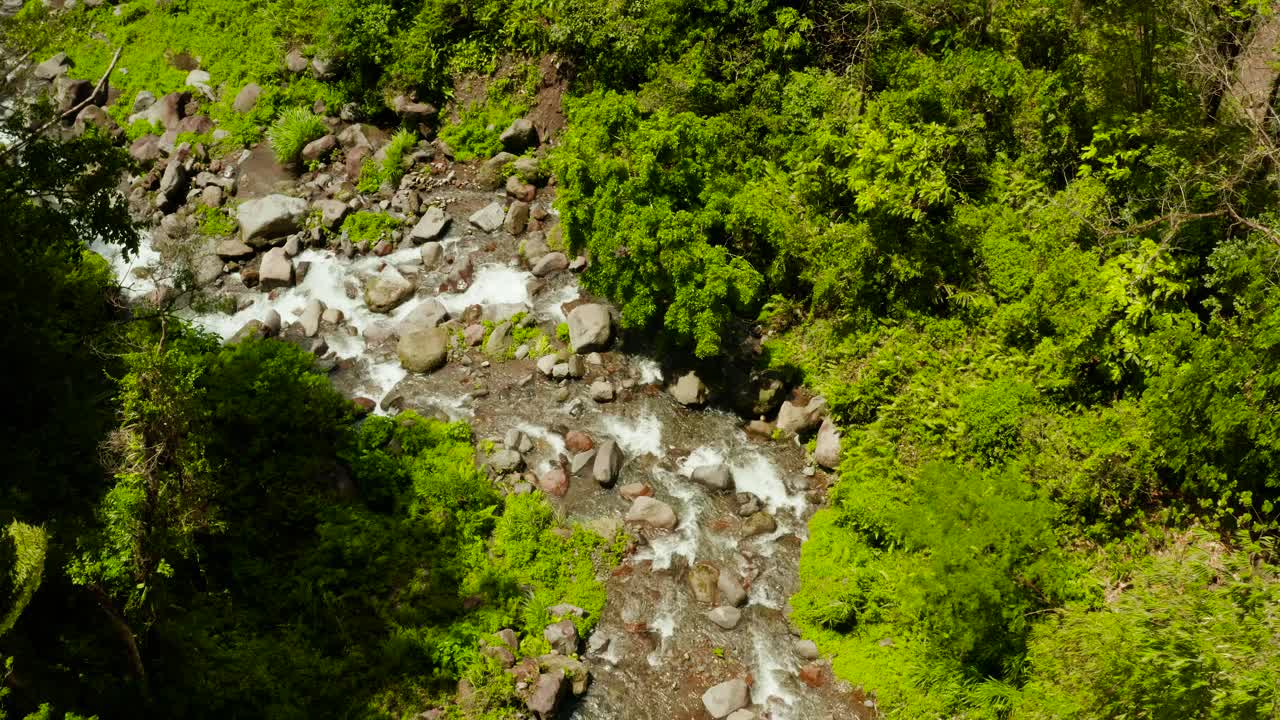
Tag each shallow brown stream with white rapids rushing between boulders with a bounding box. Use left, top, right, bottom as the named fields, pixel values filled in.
left=95, top=193, right=860, bottom=720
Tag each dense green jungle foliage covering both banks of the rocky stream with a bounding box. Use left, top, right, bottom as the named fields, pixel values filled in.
left=0, top=0, right=1280, bottom=719
